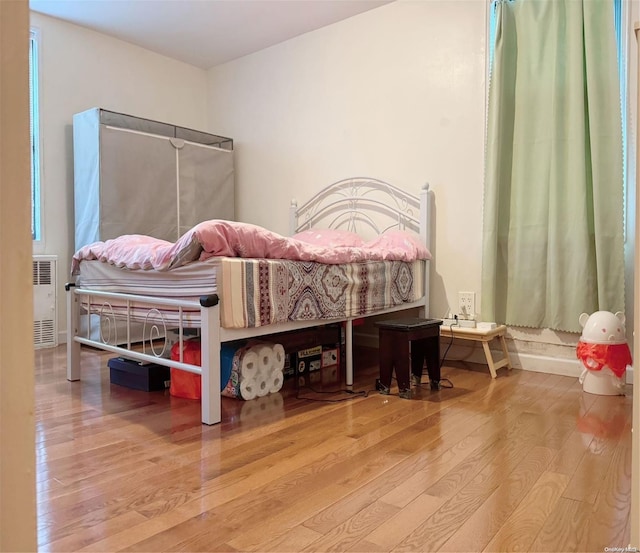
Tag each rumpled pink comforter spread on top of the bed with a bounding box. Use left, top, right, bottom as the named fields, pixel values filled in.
left=71, top=219, right=431, bottom=275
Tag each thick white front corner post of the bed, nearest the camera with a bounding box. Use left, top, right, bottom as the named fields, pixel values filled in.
left=200, top=305, right=222, bottom=424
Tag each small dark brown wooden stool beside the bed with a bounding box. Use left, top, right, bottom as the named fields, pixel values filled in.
left=375, top=318, right=442, bottom=399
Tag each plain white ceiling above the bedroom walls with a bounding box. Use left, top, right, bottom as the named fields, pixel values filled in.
left=31, top=0, right=393, bottom=69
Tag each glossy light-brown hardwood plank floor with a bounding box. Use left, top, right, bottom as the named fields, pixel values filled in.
left=36, top=347, right=632, bottom=552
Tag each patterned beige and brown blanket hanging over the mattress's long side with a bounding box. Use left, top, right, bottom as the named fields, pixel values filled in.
left=218, top=258, right=425, bottom=328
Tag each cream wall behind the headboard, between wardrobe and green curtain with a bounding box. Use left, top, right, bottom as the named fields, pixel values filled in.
left=209, top=0, right=486, bottom=322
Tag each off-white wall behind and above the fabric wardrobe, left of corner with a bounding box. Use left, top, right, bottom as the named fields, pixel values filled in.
left=31, top=12, right=207, bottom=338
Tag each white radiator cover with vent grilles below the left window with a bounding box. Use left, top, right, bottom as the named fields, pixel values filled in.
left=33, top=255, right=58, bottom=348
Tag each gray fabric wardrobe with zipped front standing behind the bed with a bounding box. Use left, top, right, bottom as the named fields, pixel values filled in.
left=73, top=108, right=234, bottom=249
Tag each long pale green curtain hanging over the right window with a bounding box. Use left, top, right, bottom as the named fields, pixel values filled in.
left=481, top=0, right=624, bottom=332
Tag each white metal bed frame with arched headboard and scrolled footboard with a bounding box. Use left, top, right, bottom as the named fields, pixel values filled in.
left=66, top=178, right=431, bottom=424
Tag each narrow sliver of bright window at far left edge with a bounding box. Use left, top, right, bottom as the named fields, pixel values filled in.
left=29, top=29, right=42, bottom=241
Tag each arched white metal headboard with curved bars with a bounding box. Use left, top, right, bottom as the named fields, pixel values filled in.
left=289, top=177, right=431, bottom=248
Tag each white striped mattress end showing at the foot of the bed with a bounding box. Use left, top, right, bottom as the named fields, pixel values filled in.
left=76, top=257, right=220, bottom=299
